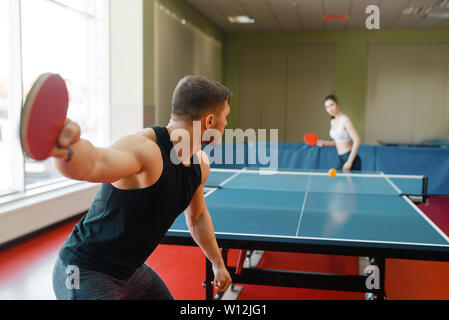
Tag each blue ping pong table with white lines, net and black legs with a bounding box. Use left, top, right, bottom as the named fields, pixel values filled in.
left=163, top=168, right=449, bottom=299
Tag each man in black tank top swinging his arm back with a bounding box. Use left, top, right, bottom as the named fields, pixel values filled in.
left=52, top=76, right=231, bottom=300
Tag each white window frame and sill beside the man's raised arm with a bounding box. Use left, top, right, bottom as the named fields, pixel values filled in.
left=0, top=0, right=110, bottom=218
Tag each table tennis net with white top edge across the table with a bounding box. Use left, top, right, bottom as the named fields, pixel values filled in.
left=205, top=169, right=427, bottom=197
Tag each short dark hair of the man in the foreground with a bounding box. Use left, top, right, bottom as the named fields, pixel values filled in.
left=172, top=76, right=232, bottom=120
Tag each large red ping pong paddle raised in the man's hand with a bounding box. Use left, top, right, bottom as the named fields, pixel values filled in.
left=20, top=73, right=71, bottom=160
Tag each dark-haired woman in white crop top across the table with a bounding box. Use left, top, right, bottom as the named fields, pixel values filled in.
left=317, top=95, right=362, bottom=171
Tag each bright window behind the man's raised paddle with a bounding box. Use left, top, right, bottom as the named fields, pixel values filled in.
left=0, top=0, right=108, bottom=195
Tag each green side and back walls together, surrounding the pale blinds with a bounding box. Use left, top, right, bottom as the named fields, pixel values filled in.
left=143, top=0, right=449, bottom=139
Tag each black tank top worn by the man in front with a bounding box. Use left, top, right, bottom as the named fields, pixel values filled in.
left=59, top=127, right=201, bottom=279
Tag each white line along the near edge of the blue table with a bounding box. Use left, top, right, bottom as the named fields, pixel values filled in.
left=168, top=229, right=449, bottom=248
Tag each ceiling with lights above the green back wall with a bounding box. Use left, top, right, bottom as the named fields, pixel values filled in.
left=185, top=0, right=449, bottom=32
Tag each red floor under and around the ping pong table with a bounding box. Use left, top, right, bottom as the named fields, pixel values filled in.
left=0, top=197, right=449, bottom=300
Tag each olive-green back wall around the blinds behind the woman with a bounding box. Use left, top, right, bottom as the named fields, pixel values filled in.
left=224, top=30, right=449, bottom=140
